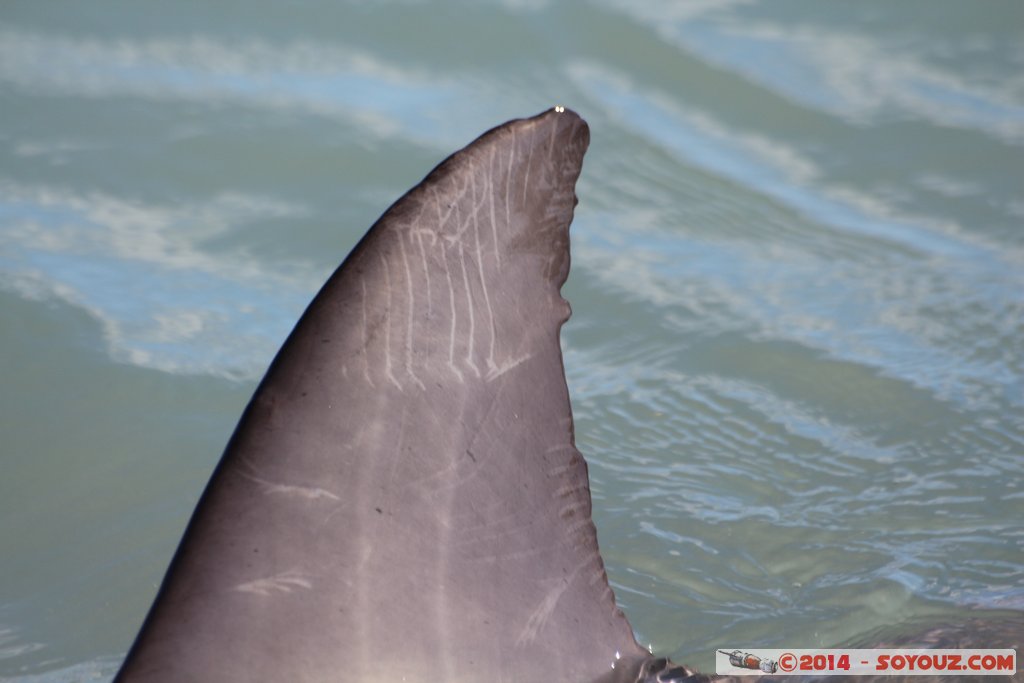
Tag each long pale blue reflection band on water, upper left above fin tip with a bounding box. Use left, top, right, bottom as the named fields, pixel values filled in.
left=0, top=29, right=455, bottom=144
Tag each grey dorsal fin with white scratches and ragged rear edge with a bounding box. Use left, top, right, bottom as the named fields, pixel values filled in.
left=119, top=108, right=647, bottom=683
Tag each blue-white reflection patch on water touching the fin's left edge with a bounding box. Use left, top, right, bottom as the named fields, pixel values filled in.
left=0, top=185, right=309, bottom=377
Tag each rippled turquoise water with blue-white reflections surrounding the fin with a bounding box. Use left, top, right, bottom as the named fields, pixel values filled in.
left=0, top=0, right=1024, bottom=683
